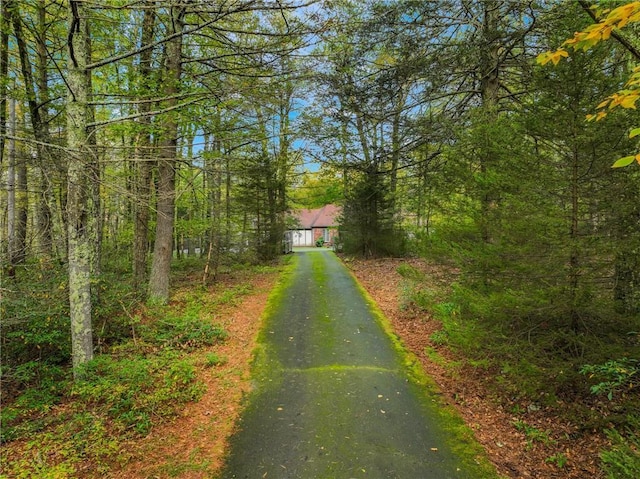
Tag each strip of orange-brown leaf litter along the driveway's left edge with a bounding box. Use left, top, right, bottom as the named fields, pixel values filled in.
left=109, top=273, right=278, bottom=479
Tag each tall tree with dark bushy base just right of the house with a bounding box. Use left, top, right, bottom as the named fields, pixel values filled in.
left=307, top=2, right=412, bottom=256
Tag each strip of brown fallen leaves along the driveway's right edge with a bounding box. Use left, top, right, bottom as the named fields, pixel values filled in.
left=346, top=258, right=606, bottom=479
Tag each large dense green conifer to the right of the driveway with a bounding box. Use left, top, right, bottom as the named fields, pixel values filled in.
left=436, top=0, right=637, bottom=344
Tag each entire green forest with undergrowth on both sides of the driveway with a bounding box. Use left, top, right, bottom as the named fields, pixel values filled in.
left=0, top=0, right=640, bottom=478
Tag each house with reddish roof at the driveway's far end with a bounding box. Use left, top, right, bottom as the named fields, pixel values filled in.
left=290, top=205, right=342, bottom=246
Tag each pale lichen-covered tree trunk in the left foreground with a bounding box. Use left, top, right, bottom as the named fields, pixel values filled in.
left=67, top=0, right=97, bottom=378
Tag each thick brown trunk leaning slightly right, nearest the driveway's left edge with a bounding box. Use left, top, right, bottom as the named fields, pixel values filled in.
left=149, top=7, right=185, bottom=303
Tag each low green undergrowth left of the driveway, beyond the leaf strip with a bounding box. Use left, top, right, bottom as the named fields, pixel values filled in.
left=0, top=262, right=264, bottom=479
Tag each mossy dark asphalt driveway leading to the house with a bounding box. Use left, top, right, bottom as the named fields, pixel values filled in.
left=221, top=250, right=496, bottom=479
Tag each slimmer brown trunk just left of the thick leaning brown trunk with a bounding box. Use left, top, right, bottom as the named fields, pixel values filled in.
left=133, top=2, right=156, bottom=291
